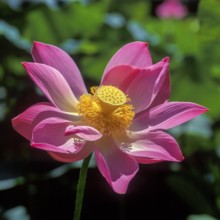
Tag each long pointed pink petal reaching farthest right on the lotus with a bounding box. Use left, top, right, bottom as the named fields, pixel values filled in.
left=131, top=102, right=207, bottom=131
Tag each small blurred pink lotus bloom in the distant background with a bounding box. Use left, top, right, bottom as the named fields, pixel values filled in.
left=156, top=0, right=188, bottom=19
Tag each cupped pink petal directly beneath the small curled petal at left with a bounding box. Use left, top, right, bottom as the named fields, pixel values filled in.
left=31, top=118, right=86, bottom=154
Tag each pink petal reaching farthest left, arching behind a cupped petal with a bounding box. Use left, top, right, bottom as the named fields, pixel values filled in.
left=12, top=102, right=80, bottom=140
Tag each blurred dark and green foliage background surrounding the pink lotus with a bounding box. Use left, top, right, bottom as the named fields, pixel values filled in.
left=0, top=0, right=220, bottom=220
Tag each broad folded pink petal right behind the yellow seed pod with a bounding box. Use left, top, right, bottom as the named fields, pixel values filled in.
left=102, top=58, right=169, bottom=113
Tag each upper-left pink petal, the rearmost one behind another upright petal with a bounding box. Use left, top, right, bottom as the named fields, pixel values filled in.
left=32, top=42, right=87, bottom=99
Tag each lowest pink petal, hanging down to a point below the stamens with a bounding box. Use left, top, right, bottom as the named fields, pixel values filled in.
left=95, top=137, right=138, bottom=194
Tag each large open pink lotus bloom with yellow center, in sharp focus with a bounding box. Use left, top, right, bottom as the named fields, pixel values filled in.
left=12, top=42, right=207, bottom=194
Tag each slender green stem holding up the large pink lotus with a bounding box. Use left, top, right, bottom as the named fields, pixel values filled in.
left=73, top=154, right=92, bottom=220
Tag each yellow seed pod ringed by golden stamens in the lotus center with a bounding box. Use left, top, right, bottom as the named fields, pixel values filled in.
left=78, top=86, right=135, bottom=135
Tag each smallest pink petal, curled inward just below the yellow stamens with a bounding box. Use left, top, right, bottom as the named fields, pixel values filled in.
left=65, top=125, right=102, bottom=141
